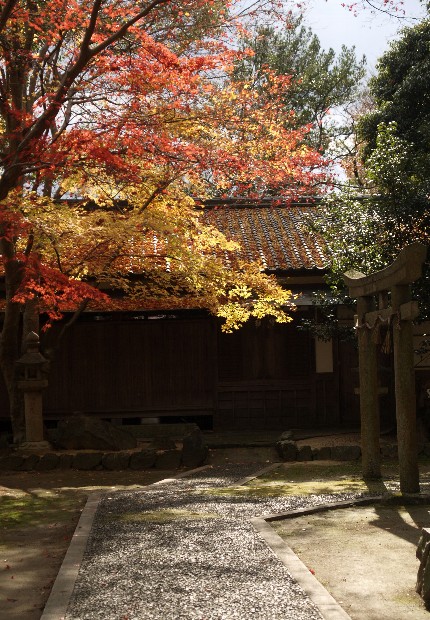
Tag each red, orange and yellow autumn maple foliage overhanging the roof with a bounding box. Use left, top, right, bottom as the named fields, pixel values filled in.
left=0, top=0, right=326, bottom=440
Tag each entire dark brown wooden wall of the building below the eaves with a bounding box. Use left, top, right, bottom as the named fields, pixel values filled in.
left=0, top=311, right=358, bottom=430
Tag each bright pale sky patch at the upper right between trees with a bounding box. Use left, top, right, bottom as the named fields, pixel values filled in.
left=305, top=0, right=424, bottom=72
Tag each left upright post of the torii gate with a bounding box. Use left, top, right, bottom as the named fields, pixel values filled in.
left=357, top=297, right=381, bottom=480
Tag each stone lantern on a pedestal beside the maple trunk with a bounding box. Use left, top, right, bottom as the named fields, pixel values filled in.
left=16, top=332, right=50, bottom=449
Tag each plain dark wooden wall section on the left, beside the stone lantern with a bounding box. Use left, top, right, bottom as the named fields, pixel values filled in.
left=45, top=315, right=215, bottom=417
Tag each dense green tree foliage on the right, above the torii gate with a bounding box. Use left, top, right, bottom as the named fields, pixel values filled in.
left=310, top=10, right=430, bottom=340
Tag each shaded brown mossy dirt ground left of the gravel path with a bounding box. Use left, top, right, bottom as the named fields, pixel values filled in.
left=0, top=470, right=176, bottom=620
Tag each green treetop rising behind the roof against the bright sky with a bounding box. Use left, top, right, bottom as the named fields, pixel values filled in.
left=235, top=15, right=366, bottom=152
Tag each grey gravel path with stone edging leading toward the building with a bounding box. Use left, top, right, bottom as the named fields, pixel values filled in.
left=65, top=464, right=366, bottom=620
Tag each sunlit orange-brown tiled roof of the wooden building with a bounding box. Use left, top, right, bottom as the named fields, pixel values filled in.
left=203, top=201, right=328, bottom=273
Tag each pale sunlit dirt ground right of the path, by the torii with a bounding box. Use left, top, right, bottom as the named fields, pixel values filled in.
left=272, top=506, right=430, bottom=620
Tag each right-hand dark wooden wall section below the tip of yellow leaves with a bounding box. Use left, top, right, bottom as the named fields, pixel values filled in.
left=216, top=321, right=337, bottom=430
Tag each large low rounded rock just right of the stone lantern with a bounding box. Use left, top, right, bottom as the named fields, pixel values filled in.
left=57, top=415, right=137, bottom=451
